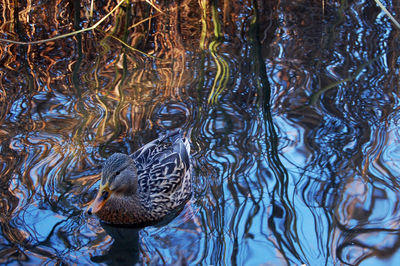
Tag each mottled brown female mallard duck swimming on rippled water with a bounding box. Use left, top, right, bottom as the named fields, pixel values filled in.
left=87, top=130, right=192, bottom=225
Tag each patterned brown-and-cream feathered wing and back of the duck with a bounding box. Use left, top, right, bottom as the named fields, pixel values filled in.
left=131, top=130, right=192, bottom=211
